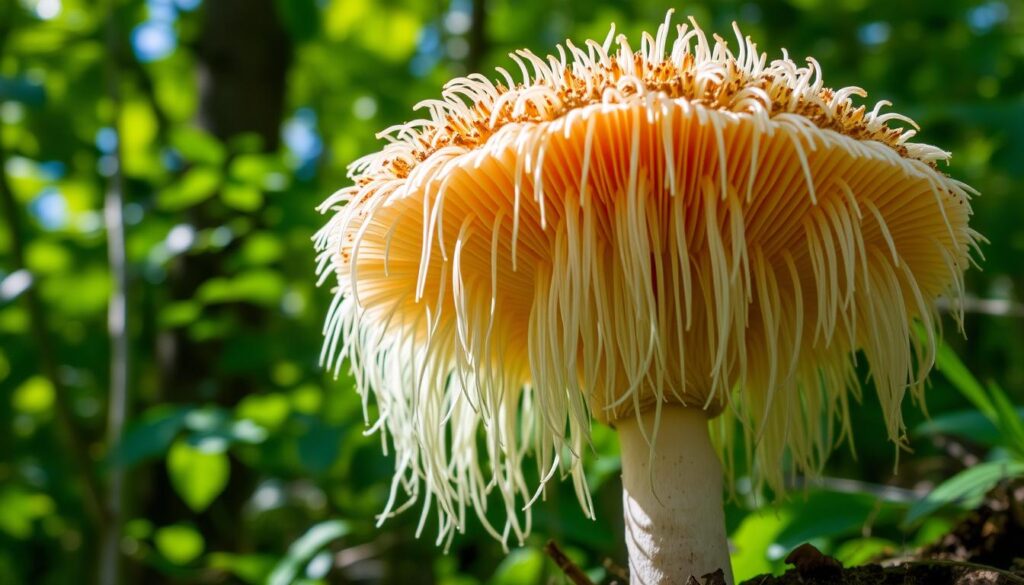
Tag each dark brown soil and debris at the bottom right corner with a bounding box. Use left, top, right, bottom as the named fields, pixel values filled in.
left=737, top=483, right=1024, bottom=585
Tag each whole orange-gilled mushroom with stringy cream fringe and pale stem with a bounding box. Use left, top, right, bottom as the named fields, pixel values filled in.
left=315, top=11, right=980, bottom=583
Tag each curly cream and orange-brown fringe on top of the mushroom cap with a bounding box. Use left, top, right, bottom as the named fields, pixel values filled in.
left=362, top=11, right=949, bottom=182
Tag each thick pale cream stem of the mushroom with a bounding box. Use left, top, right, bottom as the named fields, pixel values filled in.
left=615, top=405, right=733, bottom=585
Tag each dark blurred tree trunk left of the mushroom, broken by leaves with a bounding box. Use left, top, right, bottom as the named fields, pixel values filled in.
left=138, top=0, right=292, bottom=583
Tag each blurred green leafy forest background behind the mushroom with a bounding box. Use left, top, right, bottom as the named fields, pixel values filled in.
left=0, top=0, right=1024, bottom=585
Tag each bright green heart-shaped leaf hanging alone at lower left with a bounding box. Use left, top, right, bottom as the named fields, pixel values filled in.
left=167, top=440, right=230, bottom=512
